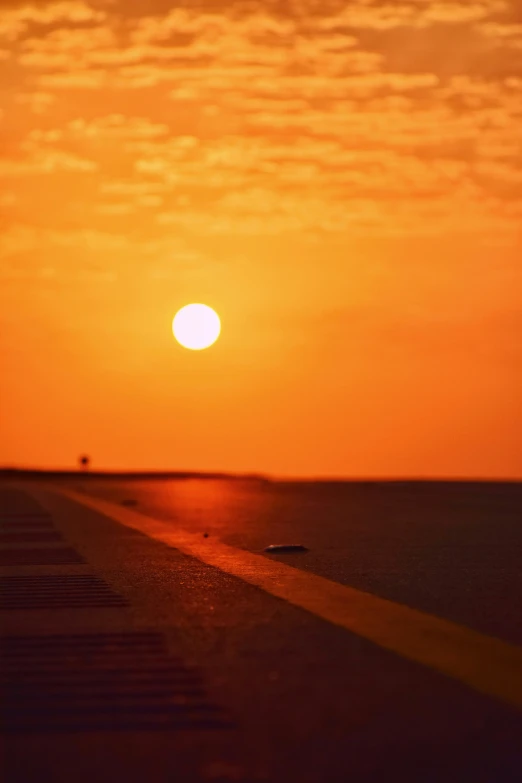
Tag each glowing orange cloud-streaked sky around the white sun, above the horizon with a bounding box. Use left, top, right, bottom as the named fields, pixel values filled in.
left=0, top=0, right=522, bottom=477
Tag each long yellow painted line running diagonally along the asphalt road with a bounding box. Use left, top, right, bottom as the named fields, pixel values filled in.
left=46, top=487, right=522, bottom=708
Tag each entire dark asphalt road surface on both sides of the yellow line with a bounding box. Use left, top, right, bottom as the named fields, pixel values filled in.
left=0, top=477, right=522, bottom=783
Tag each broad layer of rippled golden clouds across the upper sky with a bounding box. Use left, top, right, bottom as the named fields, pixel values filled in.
left=1, top=0, right=522, bottom=245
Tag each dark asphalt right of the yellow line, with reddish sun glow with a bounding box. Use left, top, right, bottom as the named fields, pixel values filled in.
left=69, top=480, right=522, bottom=644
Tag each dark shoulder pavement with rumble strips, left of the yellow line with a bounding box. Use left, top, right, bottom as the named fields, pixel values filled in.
left=0, top=478, right=522, bottom=783
